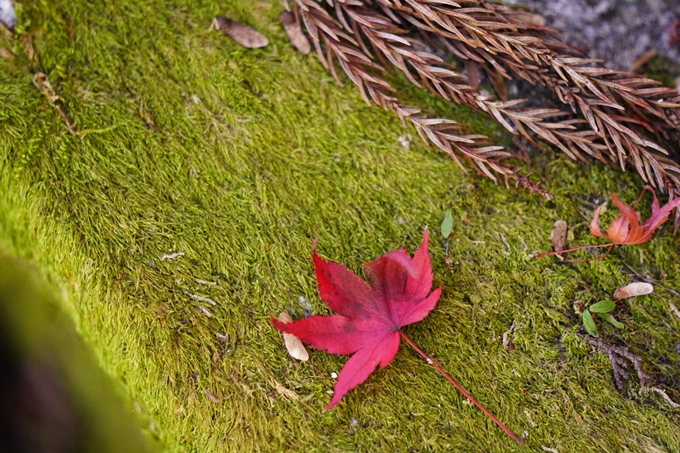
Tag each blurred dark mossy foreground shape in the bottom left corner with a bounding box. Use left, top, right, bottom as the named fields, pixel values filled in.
left=0, top=253, right=153, bottom=453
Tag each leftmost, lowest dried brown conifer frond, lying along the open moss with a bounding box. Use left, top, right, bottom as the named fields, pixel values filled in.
left=295, top=0, right=552, bottom=198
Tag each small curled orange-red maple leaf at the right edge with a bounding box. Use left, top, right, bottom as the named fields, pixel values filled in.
left=536, top=186, right=680, bottom=259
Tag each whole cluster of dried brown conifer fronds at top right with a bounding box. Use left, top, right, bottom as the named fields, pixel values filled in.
left=295, top=0, right=680, bottom=219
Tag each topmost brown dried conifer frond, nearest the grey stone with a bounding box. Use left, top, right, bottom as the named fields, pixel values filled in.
left=378, top=0, right=680, bottom=129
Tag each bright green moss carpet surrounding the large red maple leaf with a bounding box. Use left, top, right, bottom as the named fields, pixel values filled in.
left=0, top=0, right=680, bottom=453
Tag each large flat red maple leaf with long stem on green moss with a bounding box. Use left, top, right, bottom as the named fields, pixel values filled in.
left=271, top=229, right=522, bottom=443
